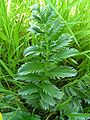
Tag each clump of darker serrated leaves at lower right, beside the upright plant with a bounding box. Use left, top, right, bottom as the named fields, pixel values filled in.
left=56, top=74, right=90, bottom=116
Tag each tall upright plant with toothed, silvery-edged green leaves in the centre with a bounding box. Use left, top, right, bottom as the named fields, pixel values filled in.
left=16, top=7, right=78, bottom=110
